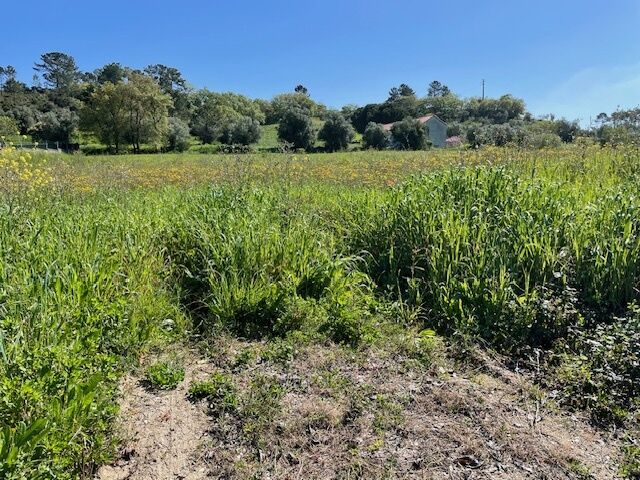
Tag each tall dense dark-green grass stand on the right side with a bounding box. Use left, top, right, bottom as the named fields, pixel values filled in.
left=344, top=167, right=640, bottom=349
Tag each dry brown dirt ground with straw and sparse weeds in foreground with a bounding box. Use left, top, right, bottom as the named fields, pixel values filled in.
left=97, top=338, right=618, bottom=480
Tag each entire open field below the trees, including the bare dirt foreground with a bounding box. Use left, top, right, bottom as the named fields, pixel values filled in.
left=0, top=146, right=640, bottom=479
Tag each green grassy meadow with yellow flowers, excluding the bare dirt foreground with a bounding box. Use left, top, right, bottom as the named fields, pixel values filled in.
left=0, top=145, right=640, bottom=479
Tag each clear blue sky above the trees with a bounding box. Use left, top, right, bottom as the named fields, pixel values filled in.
left=0, top=0, right=640, bottom=123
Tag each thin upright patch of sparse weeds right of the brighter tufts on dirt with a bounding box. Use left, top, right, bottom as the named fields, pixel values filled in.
left=240, top=375, right=285, bottom=447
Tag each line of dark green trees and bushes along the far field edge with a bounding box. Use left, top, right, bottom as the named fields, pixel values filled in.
left=0, top=52, right=640, bottom=153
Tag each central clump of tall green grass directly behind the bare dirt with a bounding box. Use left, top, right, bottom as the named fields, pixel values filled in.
left=167, top=190, right=372, bottom=343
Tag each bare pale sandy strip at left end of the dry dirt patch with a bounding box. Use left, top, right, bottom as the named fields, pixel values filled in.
left=96, top=357, right=210, bottom=480
